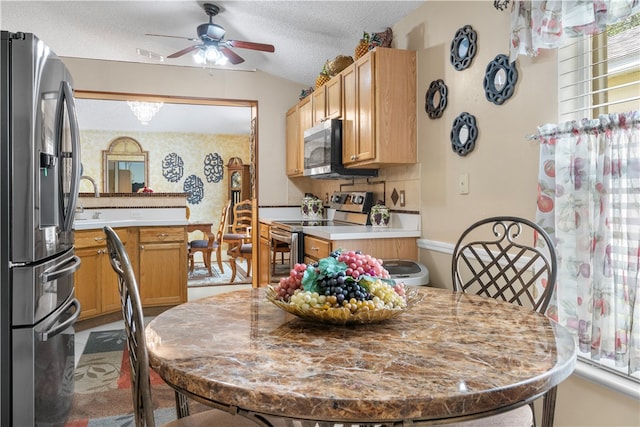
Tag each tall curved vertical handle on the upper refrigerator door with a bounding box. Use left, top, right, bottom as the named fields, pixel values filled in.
left=58, top=81, right=81, bottom=232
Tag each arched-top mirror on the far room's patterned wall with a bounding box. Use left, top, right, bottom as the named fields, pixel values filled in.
left=102, top=136, right=149, bottom=193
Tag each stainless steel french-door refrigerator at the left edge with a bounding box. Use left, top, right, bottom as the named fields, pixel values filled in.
left=0, top=31, right=80, bottom=427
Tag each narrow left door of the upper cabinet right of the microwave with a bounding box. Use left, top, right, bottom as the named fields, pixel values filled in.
left=341, top=64, right=358, bottom=165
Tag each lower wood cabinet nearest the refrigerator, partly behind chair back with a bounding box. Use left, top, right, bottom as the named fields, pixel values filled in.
left=74, top=228, right=129, bottom=320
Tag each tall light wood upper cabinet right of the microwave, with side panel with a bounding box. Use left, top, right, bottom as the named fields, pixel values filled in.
left=341, top=47, right=417, bottom=167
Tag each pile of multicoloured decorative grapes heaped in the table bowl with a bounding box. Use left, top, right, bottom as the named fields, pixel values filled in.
left=272, top=250, right=407, bottom=313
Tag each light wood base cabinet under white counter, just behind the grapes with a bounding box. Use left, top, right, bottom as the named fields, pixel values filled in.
left=304, top=235, right=418, bottom=264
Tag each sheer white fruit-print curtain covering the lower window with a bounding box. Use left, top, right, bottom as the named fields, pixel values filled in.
left=536, top=111, right=640, bottom=374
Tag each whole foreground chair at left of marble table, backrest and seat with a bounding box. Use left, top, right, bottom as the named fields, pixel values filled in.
left=104, top=227, right=256, bottom=427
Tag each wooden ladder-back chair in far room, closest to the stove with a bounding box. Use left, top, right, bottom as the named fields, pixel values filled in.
left=222, top=199, right=253, bottom=282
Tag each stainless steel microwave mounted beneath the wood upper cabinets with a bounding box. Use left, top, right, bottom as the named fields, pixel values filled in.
left=304, top=119, right=378, bottom=179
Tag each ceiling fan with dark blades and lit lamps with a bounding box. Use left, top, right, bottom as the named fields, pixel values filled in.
left=147, top=3, right=275, bottom=65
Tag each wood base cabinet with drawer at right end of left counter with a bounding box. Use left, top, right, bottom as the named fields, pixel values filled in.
left=138, top=226, right=187, bottom=307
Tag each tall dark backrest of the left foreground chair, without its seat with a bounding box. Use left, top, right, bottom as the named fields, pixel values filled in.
left=104, top=227, right=155, bottom=427
